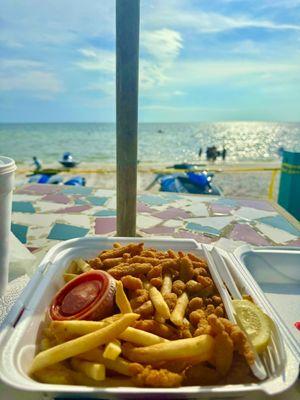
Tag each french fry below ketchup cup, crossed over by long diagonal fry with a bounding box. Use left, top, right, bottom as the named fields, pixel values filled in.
left=50, top=320, right=168, bottom=346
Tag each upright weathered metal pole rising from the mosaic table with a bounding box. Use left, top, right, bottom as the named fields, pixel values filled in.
left=116, top=0, right=140, bottom=236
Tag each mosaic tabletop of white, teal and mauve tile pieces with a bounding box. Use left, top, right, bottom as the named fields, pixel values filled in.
left=12, top=185, right=300, bottom=260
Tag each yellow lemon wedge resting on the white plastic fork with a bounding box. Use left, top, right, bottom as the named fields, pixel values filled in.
left=232, top=300, right=272, bottom=353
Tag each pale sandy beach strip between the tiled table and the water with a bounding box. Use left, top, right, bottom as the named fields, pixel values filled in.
left=16, top=161, right=280, bottom=200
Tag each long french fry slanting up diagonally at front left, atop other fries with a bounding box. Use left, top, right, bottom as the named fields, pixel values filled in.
left=30, top=313, right=139, bottom=374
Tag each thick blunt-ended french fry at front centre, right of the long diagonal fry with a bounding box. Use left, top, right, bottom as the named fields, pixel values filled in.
left=125, top=335, right=215, bottom=364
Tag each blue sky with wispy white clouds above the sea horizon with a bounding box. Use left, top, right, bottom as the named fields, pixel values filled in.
left=0, top=0, right=300, bottom=122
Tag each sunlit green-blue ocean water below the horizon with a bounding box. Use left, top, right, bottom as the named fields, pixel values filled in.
left=0, top=122, right=300, bottom=164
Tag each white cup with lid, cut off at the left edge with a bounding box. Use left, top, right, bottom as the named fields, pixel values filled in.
left=0, top=156, right=16, bottom=296
